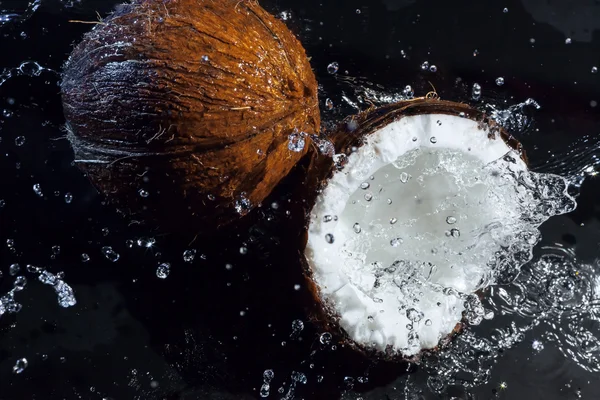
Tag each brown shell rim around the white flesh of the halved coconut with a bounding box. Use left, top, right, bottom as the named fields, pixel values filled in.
left=297, top=98, right=527, bottom=361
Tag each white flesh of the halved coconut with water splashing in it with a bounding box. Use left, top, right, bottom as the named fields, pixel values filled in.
left=305, top=114, right=573, bottom=356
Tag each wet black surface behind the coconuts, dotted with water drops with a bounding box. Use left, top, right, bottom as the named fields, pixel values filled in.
left=0, top=0, right=600, bottom=399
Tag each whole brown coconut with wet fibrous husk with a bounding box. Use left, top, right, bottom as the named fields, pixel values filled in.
left=61, top=0, right=320, bottom=229
